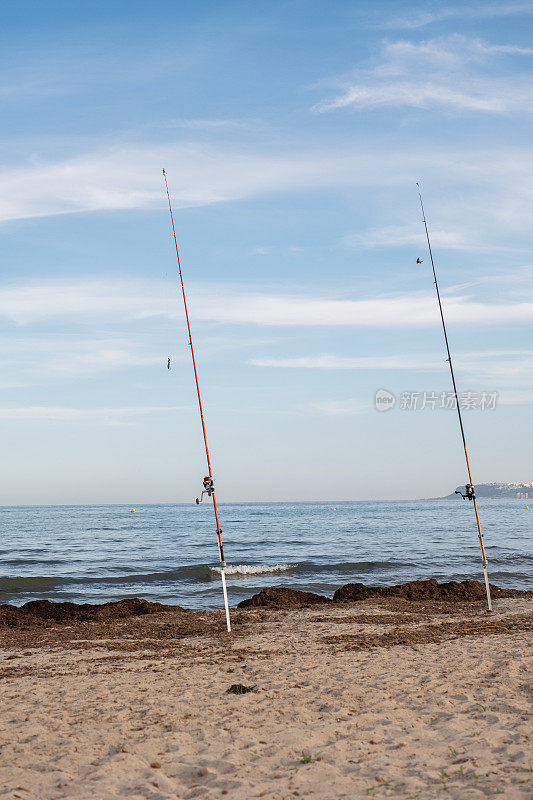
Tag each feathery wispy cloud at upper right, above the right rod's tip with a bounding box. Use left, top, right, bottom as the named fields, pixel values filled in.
left=315, top=35, right=533, bottom=114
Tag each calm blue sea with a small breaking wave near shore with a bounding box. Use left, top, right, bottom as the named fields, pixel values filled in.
left=0, top=500, right=533, bottom=608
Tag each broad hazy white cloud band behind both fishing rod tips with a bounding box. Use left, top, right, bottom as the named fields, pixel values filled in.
left=0, top=138, right=533, bottom=256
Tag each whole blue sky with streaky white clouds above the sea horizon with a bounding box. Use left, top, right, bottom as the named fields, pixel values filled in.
left=0, top=0, right=533, bottom=504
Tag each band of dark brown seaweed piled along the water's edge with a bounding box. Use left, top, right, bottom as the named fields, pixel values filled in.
left=0, top=580, right=533, bottom=660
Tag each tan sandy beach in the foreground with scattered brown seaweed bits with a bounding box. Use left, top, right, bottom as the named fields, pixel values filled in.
left=0, top=599, right=533, bottom=800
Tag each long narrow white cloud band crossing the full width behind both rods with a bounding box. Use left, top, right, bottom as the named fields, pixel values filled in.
left=0, top=280, right=533, bottom=327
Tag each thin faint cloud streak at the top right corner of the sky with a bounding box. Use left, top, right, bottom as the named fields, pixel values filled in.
left=377, top=3, right=533, bottom=29
